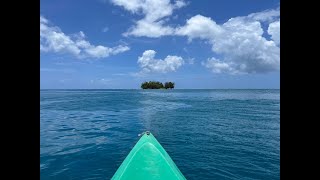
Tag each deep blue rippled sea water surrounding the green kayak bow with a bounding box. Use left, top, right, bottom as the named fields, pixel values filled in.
left=40, top=90, right=280, bottom=180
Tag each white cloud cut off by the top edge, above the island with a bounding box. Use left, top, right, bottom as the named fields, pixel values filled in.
left=111, top=0, right=186, bottom=38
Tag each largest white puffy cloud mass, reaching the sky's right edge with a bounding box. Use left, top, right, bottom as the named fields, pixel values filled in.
left=175, top=11, right=280, bottom=74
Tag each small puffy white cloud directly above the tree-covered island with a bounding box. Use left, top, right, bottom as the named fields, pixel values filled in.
left=138, top=50, right=184, bottom=73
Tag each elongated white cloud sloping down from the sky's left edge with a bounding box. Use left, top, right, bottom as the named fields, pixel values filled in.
left=40, top=16, right=130, bottom=58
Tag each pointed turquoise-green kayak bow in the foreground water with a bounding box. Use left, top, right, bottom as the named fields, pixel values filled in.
left=112, top=131, right=186, bottom=180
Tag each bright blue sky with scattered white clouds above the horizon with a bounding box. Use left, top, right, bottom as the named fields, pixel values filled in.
left=40, top=0, right=280, bottom=89
